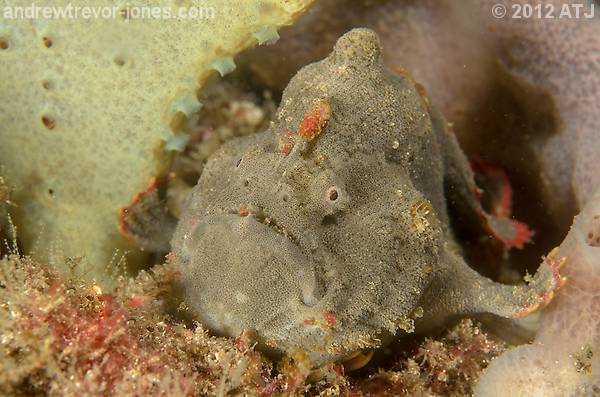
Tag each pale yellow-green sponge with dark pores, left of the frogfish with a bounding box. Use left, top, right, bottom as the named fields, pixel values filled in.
left=0, top=0, right=313, bottom=281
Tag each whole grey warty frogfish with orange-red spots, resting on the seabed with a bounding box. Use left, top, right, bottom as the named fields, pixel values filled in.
left=170, top=29, right=561, bottom=365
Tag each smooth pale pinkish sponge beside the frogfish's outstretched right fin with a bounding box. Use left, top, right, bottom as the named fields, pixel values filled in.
left=475, top=190, right=600, bottom=397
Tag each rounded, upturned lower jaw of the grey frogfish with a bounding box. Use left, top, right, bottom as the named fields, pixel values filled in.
left=179, top=211, right=319, bottom=339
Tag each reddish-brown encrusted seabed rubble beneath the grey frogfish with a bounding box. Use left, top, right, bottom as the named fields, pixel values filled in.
left=0, top=255, right=504, bottom=397
